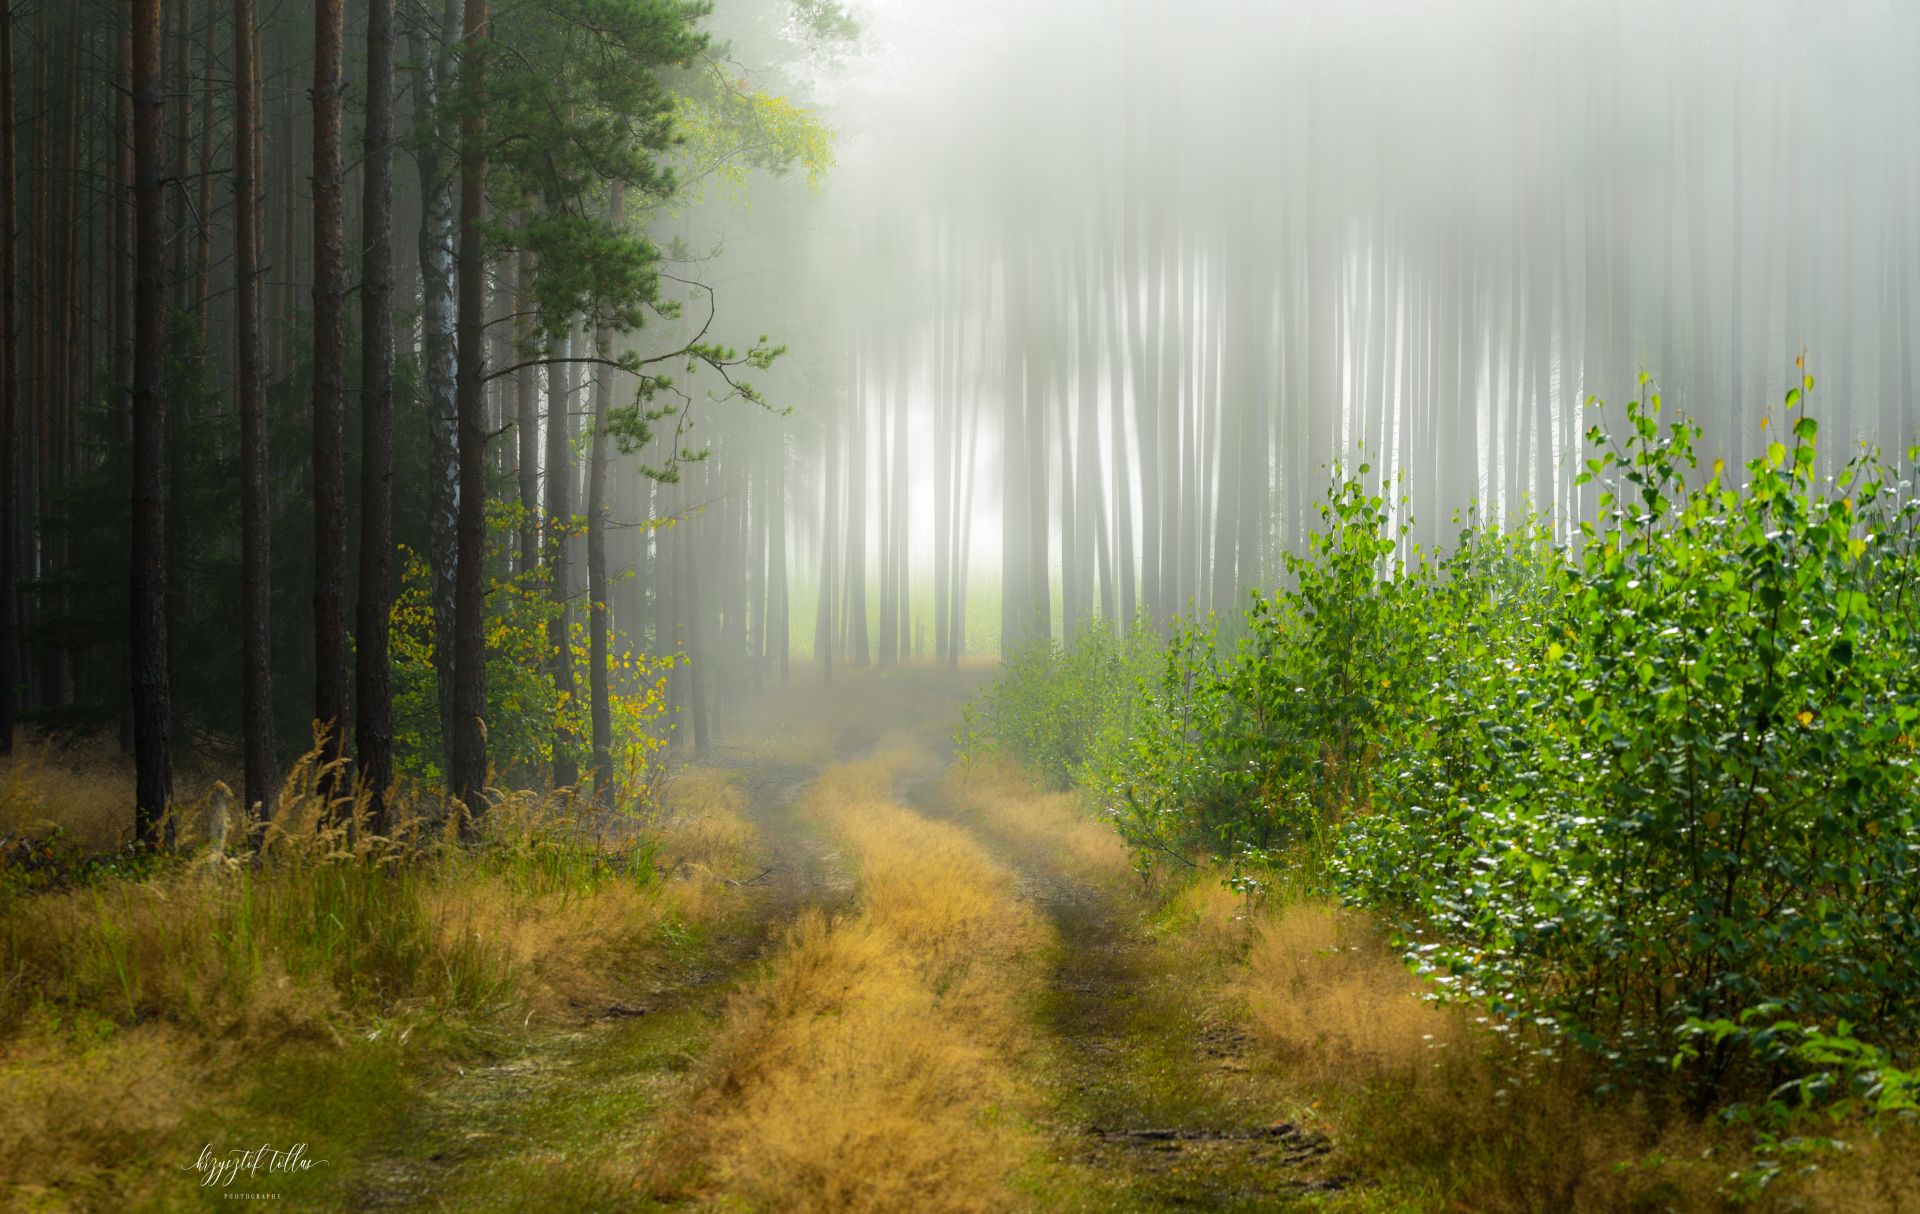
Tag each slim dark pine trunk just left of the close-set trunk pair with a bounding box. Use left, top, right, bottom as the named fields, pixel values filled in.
left=234, top=0, right=278, bottom=814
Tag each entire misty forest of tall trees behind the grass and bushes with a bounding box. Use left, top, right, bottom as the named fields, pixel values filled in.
left=0, top=0, right=1920, bottom=824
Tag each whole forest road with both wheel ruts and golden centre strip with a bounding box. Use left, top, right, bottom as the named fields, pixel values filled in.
left=342, top=670, right=1348, bottom=1210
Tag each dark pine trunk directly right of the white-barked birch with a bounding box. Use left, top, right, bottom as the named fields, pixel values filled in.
left=447, top=0, right=488, bottom=830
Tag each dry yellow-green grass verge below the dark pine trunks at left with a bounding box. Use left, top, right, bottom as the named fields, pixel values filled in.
left=0, top=745, right=756, bottom=1208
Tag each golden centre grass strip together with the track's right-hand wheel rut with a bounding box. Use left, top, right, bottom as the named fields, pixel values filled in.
left=637, top=684, right=1352, bottom=1210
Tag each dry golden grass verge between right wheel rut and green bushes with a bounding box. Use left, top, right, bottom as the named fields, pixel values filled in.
left=1240, top=899, right=1774, bottom=1214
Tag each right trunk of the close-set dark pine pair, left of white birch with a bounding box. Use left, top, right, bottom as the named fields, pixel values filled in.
left=353, top=0, right=394, bottom=834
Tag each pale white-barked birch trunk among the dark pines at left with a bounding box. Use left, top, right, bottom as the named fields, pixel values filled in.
left=409, top=0, right=461, bottom=772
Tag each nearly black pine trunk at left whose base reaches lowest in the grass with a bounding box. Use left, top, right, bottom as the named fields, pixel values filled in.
left=129, top=0, right=173, bottom=847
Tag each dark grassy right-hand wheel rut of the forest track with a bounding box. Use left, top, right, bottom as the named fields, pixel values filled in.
left=922, top=776, right=1350, bottom=1210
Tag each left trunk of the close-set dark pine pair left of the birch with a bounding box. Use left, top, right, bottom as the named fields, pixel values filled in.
left=313, top=0, right=348, bottom=776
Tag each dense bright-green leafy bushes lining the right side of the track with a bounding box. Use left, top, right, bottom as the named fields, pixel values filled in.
left=989, top=376, right=1920, bottom=1110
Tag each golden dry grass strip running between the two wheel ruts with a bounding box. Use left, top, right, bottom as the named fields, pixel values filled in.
left=659, top=751, right=1046, bottom=1214
